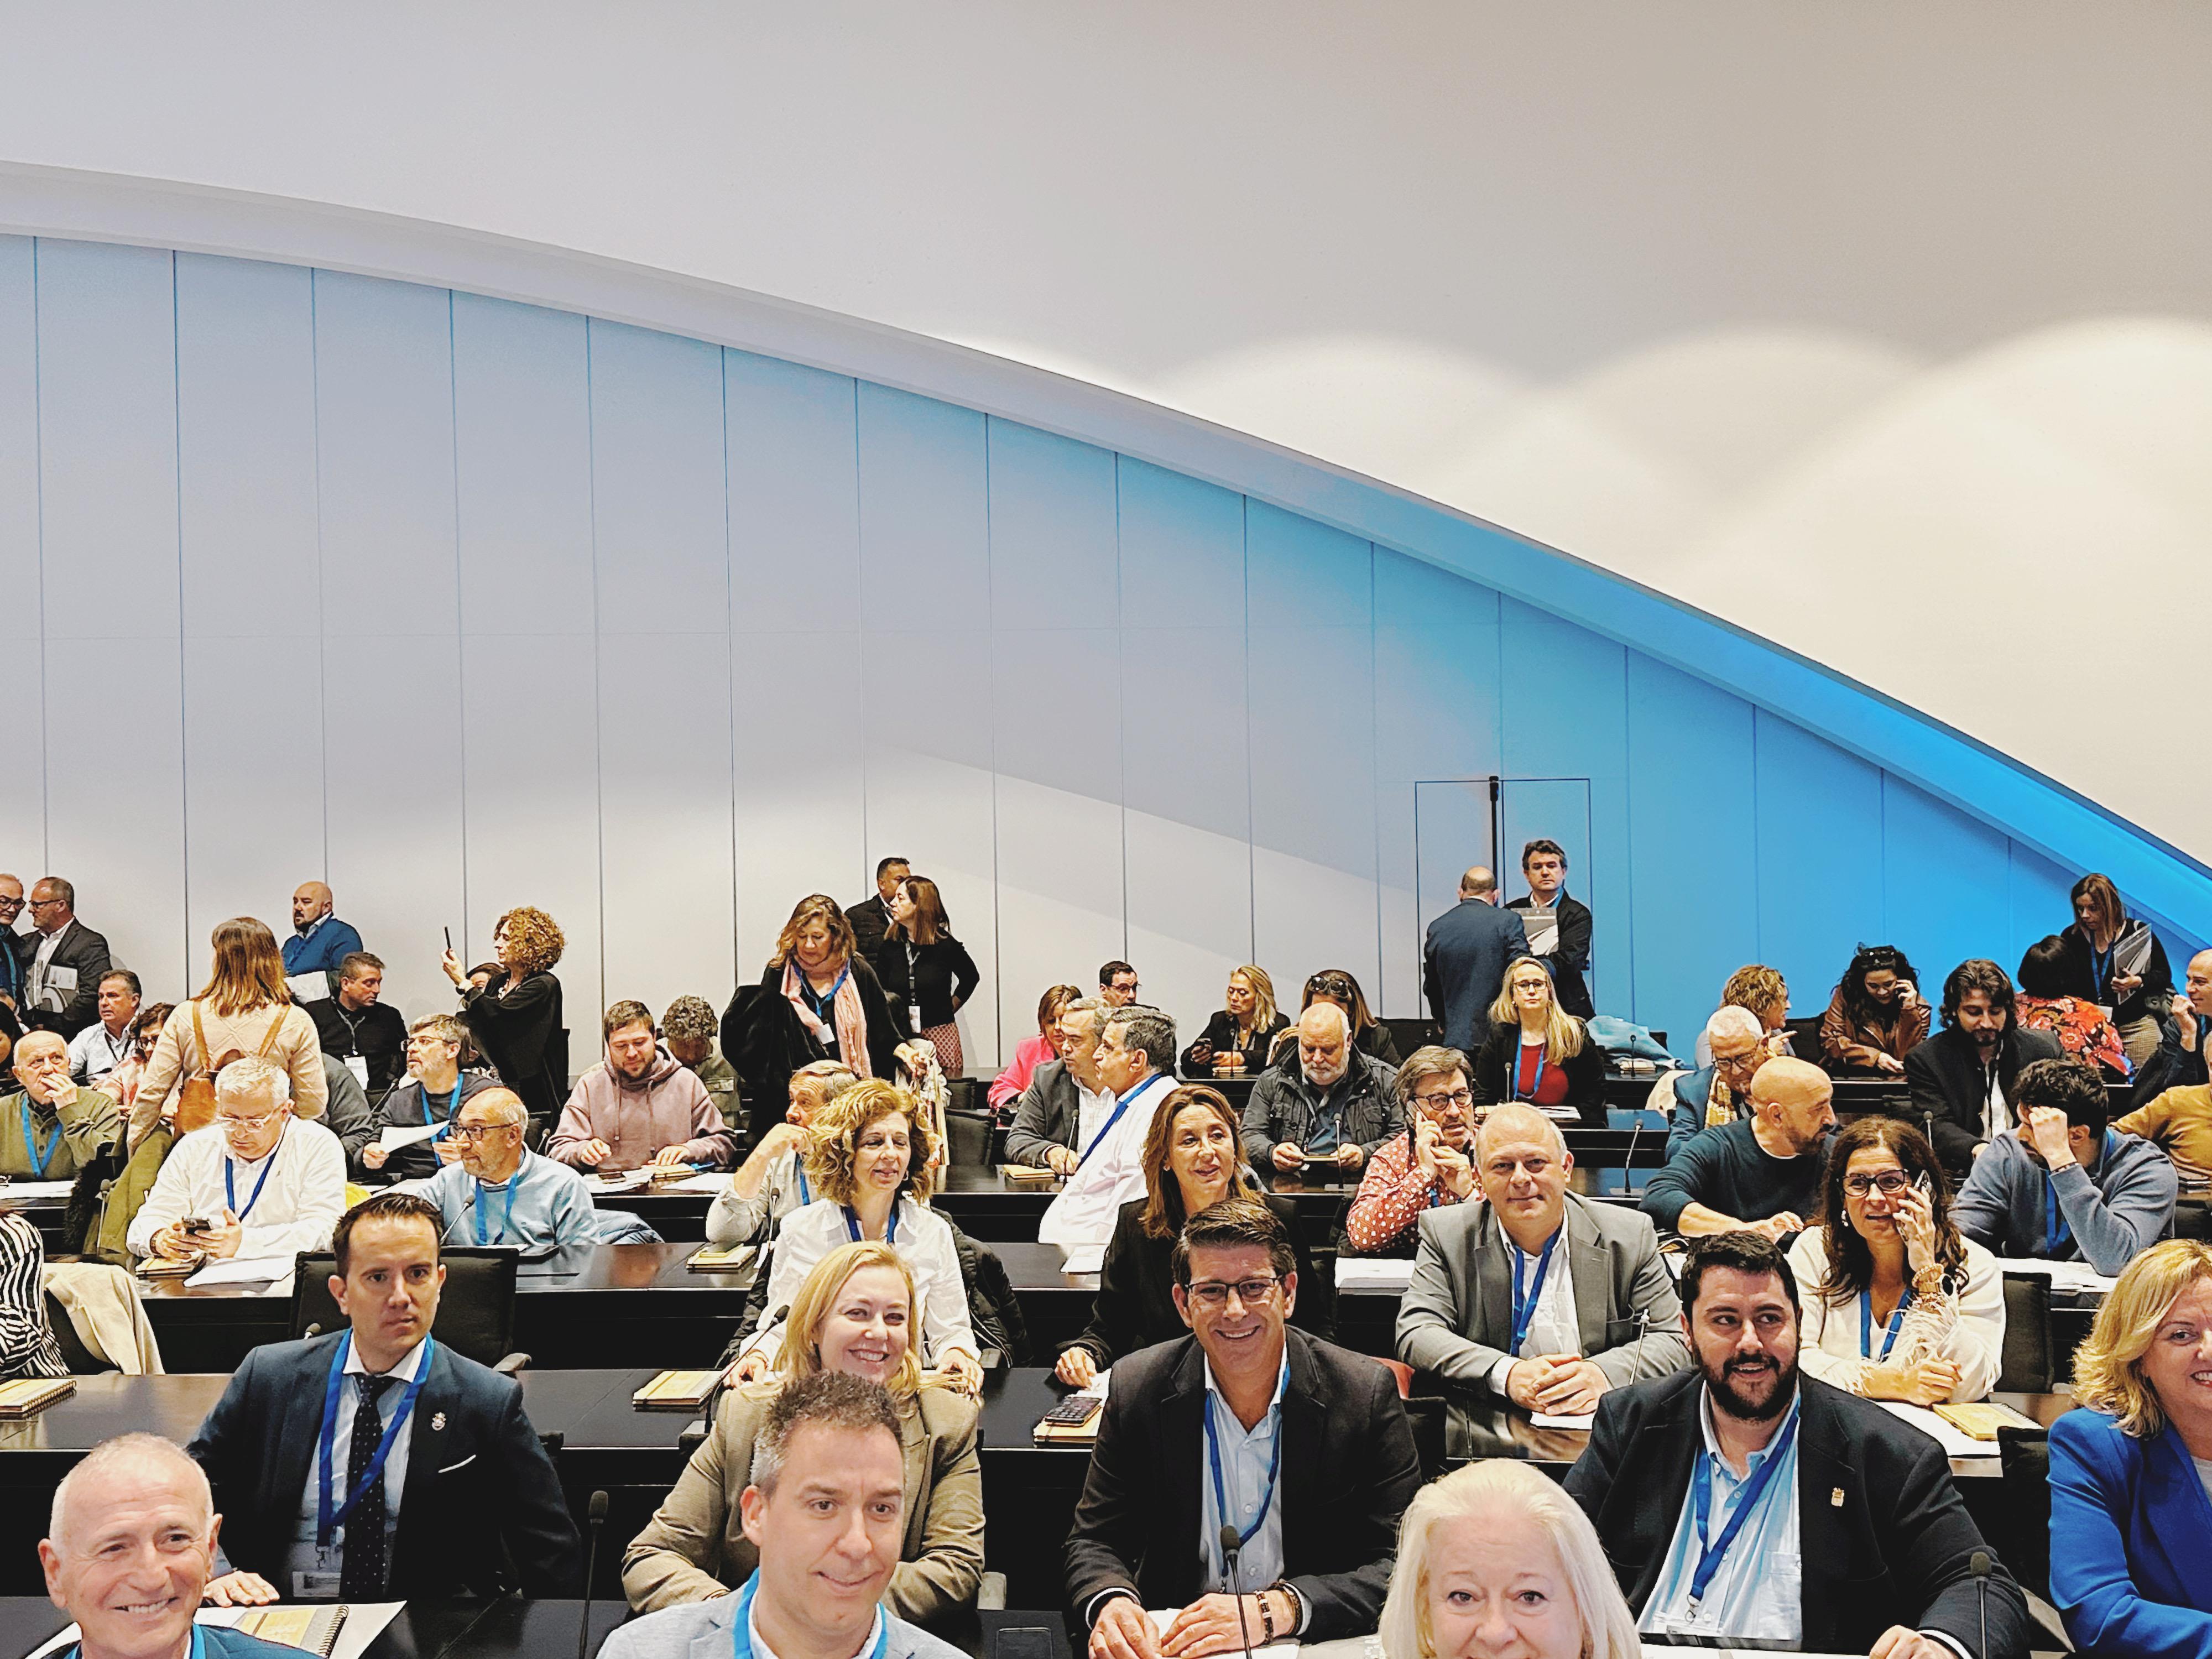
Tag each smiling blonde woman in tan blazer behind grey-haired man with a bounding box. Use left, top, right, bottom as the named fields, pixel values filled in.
left=622, top=1241, right=982, bottom=1621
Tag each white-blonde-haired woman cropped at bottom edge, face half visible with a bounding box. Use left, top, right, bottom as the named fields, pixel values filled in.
left=1378, top=1458, right=1644, bottom=1659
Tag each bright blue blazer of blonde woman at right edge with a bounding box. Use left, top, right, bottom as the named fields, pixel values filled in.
left=2051, top=1409, right=2212, bottom=1659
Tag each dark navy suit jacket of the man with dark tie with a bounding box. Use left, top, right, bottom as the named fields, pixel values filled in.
left=186, top=1336, right=584, bottom=1599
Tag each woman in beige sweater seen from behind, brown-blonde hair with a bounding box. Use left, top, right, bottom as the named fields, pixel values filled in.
left=128, top=916, right=330, bottom=1150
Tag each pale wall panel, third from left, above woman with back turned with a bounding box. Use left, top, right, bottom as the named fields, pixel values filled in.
left=177, top=254, right=327, bottom=942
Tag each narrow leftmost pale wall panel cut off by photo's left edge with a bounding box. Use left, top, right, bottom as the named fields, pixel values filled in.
left=0, top=237, right=46, bottom=885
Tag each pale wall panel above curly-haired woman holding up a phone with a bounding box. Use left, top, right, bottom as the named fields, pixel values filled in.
left=453, top=294, right=602, bottom=1035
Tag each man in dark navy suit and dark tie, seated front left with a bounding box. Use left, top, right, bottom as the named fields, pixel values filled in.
left=188, top=1192, right=584, bottom=1604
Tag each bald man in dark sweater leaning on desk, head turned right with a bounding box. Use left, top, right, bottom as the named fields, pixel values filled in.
left=1639, top=1057, right=1836, bottom=1243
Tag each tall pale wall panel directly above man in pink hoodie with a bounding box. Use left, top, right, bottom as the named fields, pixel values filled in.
left=588, top=323, right=737, bottom=1013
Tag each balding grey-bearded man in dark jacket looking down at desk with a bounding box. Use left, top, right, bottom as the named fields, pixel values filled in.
left=1243, top=1002, right=1405, bottom=1172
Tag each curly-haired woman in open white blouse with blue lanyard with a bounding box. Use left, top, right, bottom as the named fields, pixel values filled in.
left=737, top=1077, right=982, bottom=1394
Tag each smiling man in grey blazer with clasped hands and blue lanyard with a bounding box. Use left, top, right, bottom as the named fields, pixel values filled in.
left=1398, top=1106, right=1690, bottom=1451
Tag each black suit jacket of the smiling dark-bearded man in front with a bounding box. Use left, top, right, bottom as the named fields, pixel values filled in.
left=1566, top=1371, right=2028, bottom=1659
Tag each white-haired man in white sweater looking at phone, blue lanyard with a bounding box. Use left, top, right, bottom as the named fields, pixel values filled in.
left=126, top=1055, right=345, bottom=1272
